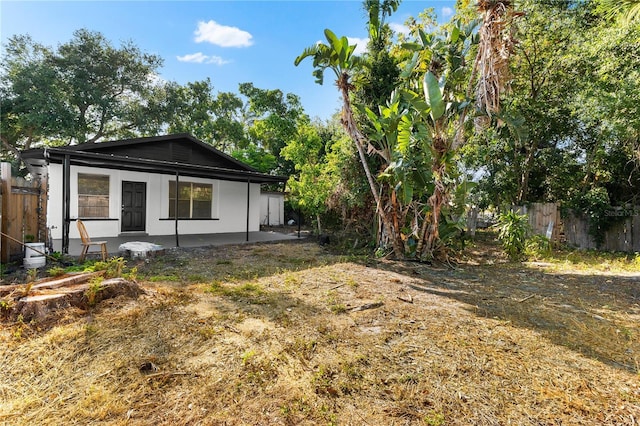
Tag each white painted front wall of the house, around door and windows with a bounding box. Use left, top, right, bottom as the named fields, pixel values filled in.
left=47, top=164, right=260, bottom=239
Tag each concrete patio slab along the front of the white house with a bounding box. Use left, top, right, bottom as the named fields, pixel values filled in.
left=53, top=231, right=305, bottom=258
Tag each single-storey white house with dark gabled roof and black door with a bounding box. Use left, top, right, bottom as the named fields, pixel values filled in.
left=22, top=134, right=287, bottom=252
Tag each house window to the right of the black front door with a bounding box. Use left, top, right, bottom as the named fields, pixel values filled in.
left=169, top=180, right=213, bottom=219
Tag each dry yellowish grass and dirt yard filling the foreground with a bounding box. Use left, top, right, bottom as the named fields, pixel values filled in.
left=0, top=238, right=640, bottom=425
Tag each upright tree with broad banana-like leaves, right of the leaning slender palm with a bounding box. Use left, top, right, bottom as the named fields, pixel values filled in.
left=369, top=19, right=474, bottom=259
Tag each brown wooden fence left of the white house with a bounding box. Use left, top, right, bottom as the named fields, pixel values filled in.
left=0, top=163, right=47, bottom=263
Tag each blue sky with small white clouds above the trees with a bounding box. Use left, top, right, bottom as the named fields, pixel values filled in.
left=0, top=0, right=455, bottom=119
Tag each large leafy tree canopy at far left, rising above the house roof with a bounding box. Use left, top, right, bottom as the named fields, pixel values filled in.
left=1, top=29, right=162, bottom=149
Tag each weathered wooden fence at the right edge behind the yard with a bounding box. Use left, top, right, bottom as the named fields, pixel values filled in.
left=517, top=203, right=640, bottom=252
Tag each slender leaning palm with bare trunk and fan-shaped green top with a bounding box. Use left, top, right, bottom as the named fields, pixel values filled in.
left=294, top=29, right=403, bottom=258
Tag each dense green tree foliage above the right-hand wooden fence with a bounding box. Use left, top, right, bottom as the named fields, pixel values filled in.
left=462, top=0, right=640, bottom=210
